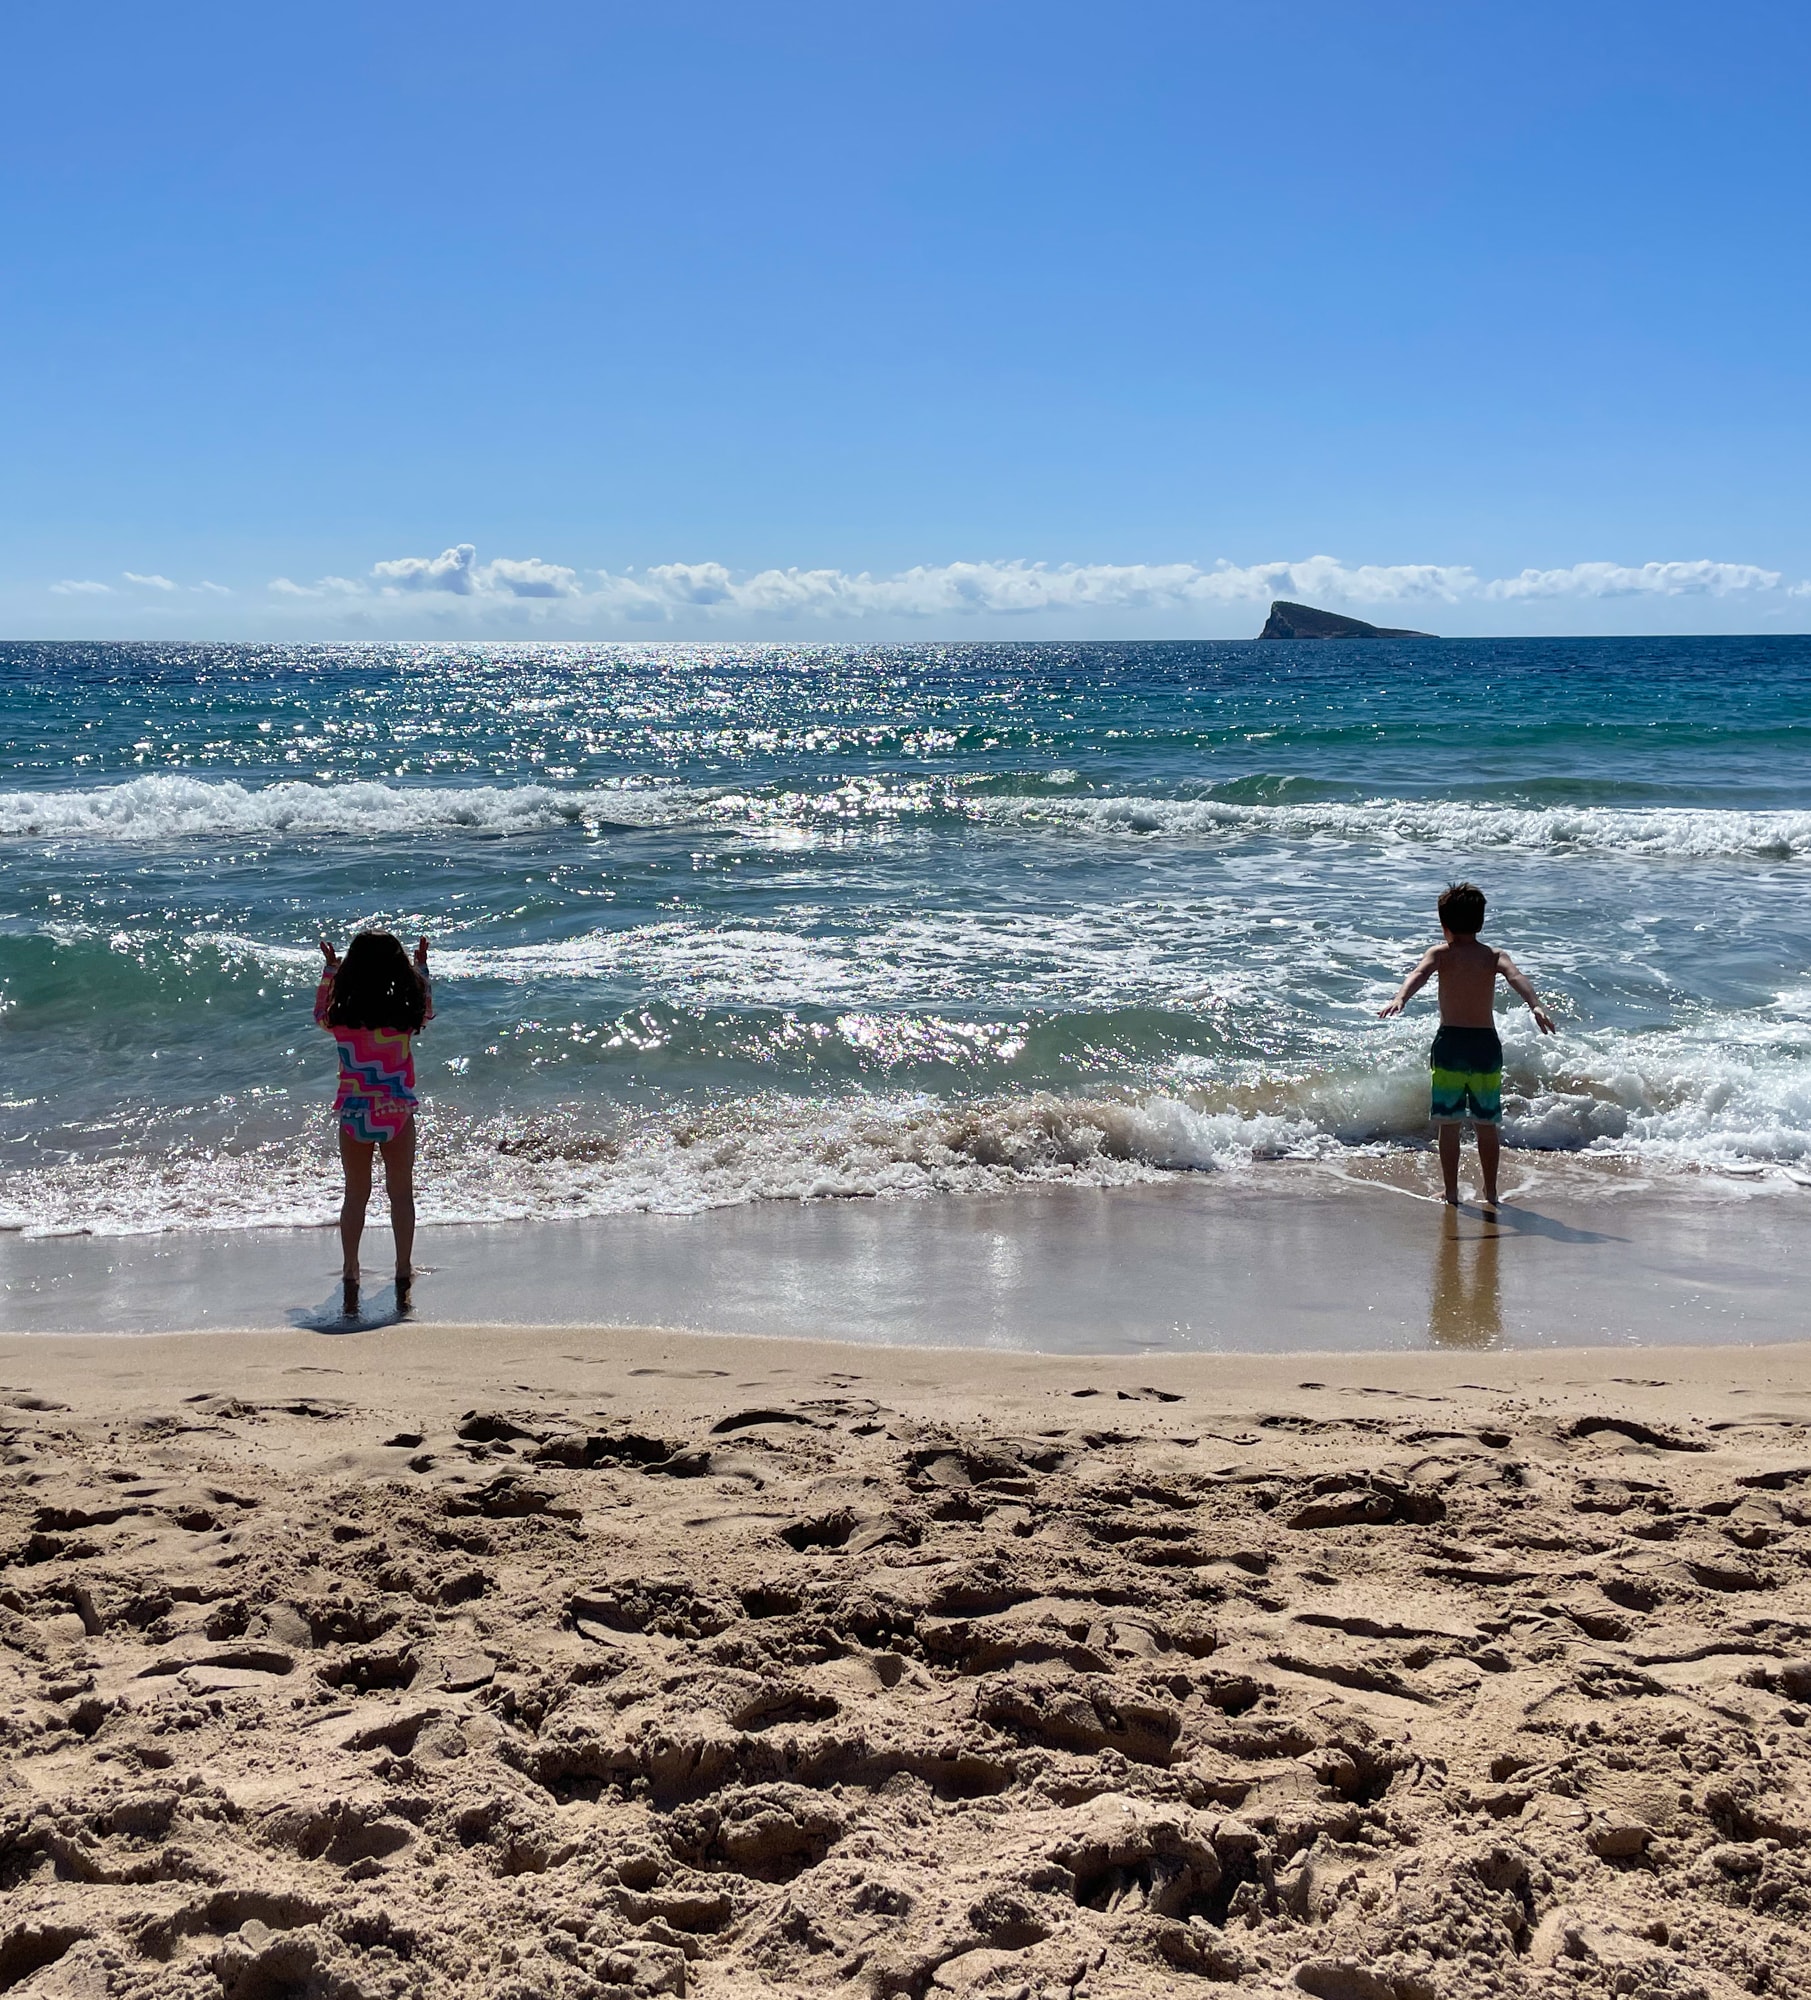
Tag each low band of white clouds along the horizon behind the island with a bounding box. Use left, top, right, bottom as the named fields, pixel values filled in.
left=35, top=542, right=1811, bottom=640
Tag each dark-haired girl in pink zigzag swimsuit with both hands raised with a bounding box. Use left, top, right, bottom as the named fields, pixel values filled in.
left=314, top=930, right=434, bottom=1320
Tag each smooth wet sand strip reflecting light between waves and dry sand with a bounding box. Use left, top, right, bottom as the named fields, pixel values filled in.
left=0, top=1156, right=1811, bottom=1354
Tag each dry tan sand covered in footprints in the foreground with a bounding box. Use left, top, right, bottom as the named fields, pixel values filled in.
left=0, top=1328, right=1811, bottom=2000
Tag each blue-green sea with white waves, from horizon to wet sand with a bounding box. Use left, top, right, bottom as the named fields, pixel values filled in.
left=0, top=638, right=1811, bottom=1232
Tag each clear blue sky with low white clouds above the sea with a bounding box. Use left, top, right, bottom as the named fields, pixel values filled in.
left=0, top=0, right=1811, bottom=638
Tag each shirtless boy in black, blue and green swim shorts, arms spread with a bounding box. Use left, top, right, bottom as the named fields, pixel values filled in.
left=1377, top=882, right=1555, bottom=1208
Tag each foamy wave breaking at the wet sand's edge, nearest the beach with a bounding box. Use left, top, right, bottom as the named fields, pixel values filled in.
left=0, top=1010, right=1811, bottom=1234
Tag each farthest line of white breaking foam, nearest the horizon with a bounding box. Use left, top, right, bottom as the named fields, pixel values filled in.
left=0, top=772, right=1811, bottom=860
